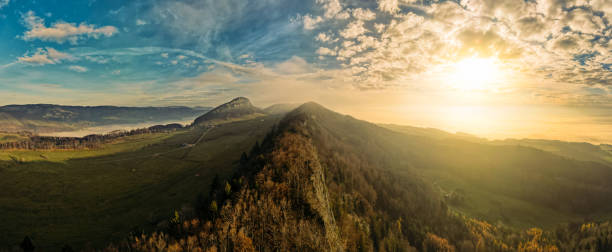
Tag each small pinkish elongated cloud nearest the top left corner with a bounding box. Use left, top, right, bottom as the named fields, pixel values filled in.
left=22, top=11, right=119, bottom=44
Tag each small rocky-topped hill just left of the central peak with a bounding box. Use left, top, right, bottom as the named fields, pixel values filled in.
left=193, top=97, right=265, bottom=125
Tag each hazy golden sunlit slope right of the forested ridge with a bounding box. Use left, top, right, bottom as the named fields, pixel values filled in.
left=298, top=103, right=612, bottom=228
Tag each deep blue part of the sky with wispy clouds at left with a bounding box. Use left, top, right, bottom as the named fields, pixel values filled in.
left=0, top=0, right=322, bottom=105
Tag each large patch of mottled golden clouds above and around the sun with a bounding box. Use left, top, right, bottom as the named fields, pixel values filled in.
left=305, top=0, right=612, bottom=89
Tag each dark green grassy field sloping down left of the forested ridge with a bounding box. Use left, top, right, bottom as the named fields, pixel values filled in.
left=0, top=117, right=279, bottom=250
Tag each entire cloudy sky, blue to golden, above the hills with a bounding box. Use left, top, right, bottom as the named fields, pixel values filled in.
left=0, top=0, right=612, bottom=143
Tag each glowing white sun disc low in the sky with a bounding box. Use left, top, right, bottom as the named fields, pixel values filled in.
left=446, top=57, right=504, bottom=91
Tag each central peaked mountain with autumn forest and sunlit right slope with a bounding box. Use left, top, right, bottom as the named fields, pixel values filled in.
left=113, top=103, right=612, bottom=251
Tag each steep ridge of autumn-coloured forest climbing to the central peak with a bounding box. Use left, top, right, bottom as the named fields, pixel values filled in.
left=99, top=103, right=612, bottom=251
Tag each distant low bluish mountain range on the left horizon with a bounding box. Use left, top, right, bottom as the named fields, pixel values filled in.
left=0, top=104, right=208, bottom=133
